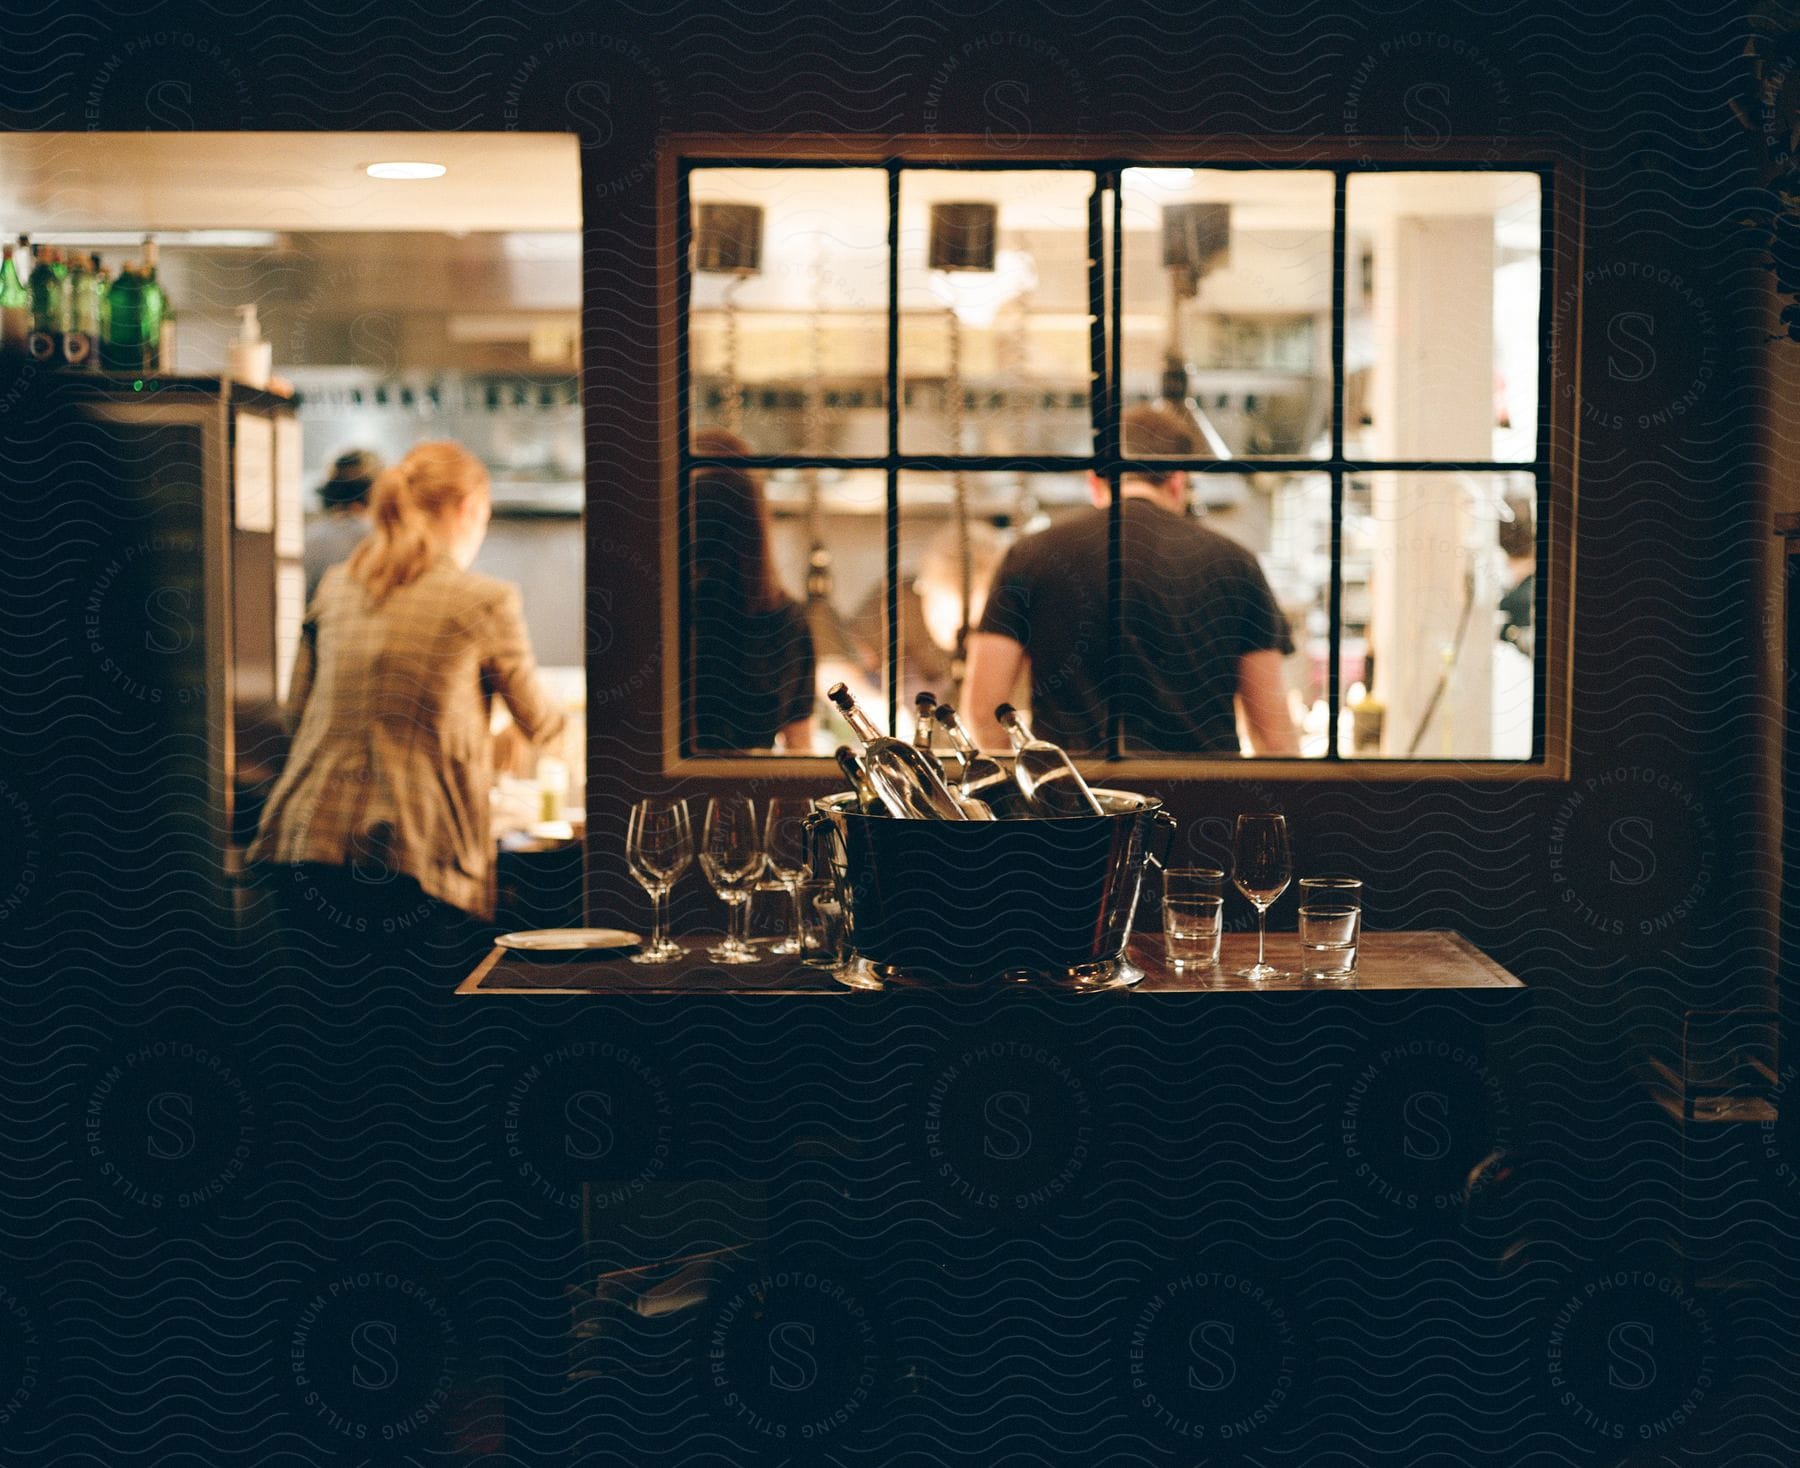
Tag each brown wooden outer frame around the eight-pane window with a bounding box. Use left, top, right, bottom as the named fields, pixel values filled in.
left=655, top=133, right=1584, bottom=784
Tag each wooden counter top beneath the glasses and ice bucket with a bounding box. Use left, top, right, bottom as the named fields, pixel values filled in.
left=457, top=932, right=1523, bottom=997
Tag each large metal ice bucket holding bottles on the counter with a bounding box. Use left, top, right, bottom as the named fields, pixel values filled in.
left=815, top=790, right=1175, bottom=984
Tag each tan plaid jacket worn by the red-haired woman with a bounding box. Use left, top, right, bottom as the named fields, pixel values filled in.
left=248, top=556, right=563, bottom=918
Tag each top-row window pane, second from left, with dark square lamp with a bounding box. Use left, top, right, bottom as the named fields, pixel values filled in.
left=900, top=169, right=1094, bottom=453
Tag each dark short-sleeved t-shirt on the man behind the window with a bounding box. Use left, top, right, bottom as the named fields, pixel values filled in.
left=981, top=497, right=1292, bottom=754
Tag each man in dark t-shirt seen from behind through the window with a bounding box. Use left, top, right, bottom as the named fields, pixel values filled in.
left=963, top=407, right=1298, bottom=754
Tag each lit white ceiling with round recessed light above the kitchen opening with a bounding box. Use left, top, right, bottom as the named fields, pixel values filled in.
left=0, top=133, right=581, bottom=236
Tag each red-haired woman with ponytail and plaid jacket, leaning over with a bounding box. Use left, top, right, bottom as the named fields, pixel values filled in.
left=250, top=443, right=562, bottom=957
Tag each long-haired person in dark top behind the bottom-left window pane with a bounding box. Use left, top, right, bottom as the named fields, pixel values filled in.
left=688, top=428, right=817, bottom=754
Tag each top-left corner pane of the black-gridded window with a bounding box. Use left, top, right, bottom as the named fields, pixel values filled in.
left=688, top=167, right=887, bottom=457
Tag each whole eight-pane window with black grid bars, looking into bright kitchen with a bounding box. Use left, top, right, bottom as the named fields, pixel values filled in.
left=677, top=158, right=1553, bottom=765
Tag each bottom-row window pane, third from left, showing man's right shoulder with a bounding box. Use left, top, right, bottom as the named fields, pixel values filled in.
left=1120, top=473, right=1332, bottom=757
